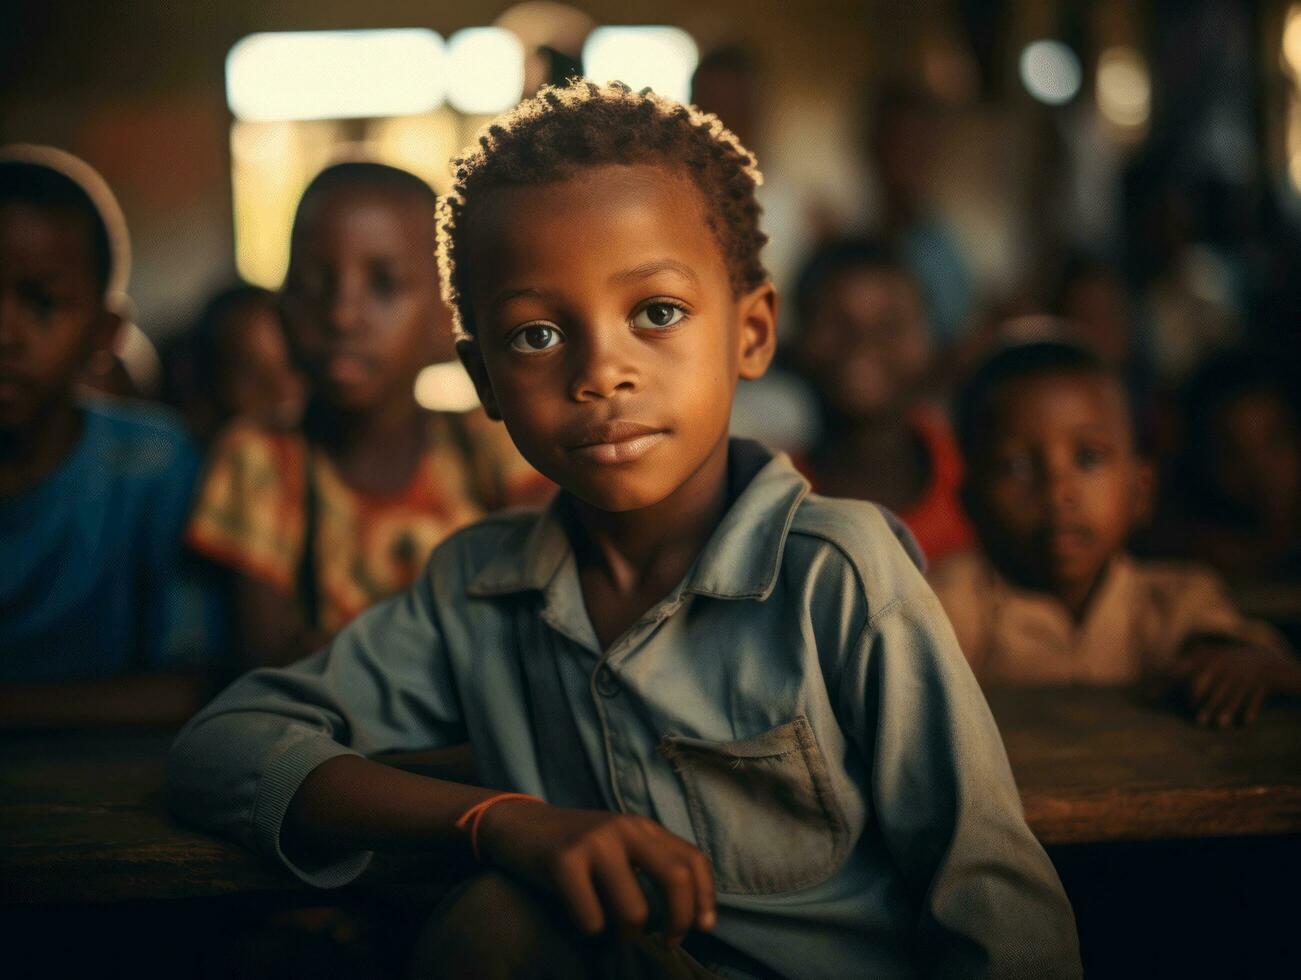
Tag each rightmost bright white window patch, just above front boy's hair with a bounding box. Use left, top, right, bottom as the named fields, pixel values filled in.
left=583, top=27, right=700, bottom=102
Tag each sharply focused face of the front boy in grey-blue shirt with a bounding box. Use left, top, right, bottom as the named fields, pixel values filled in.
left=461, top=165, right=775, bottom=511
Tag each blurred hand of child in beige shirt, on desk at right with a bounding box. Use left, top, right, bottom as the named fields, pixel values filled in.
left=1170, top=640, right=1301, bottom=728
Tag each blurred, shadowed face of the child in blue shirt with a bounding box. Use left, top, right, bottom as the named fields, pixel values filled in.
left=0, top=202, right=120, bottom=433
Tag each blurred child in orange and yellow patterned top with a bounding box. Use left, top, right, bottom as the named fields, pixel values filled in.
left=187, top=163, right=549, bottom=664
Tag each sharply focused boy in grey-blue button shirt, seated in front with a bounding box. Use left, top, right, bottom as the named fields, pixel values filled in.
left=169, top=82, right=1079, bottom=977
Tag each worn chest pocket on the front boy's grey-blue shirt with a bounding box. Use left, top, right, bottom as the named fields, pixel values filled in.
left=660, top=715, right=850, bottom=895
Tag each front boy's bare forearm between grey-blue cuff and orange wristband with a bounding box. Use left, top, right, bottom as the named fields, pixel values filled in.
left=280, top=755, right=497, bottom=863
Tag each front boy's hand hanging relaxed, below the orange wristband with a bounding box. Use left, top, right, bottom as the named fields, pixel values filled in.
left=479, top=800, right=717, bottom=942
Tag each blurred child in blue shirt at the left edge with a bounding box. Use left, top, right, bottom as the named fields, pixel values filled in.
left=0, top=147, right=218, bottom=726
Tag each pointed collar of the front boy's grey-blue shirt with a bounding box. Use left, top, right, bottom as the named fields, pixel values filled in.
left=467, top=439, right=809, bottom=599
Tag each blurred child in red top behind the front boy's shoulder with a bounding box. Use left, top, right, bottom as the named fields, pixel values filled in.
left=791, top=232, right=972, bottom=561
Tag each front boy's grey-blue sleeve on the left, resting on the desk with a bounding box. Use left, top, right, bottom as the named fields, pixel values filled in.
left=168, top=575, right=464, bottom=886
